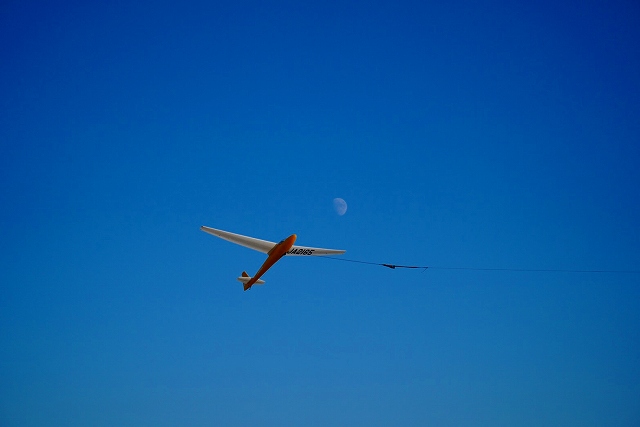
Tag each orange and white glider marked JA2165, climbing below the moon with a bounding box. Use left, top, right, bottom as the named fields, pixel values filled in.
left=200, top=225, right=346, bottom=291
